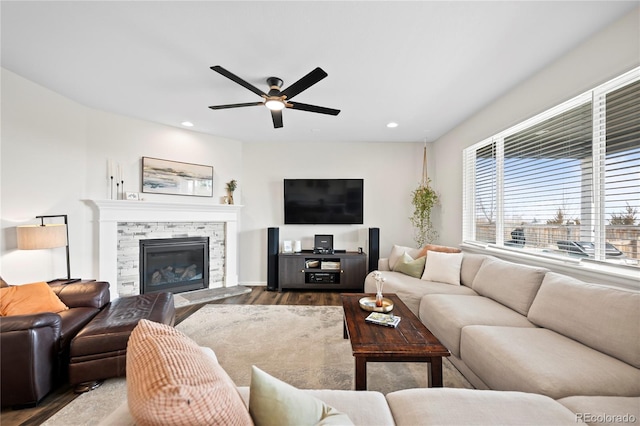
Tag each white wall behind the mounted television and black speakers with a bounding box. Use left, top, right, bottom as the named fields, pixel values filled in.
left=240, top=142, right=422, bottom=284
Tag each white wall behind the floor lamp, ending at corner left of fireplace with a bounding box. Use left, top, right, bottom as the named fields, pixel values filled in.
left=1, top=70, right=87, bottom=283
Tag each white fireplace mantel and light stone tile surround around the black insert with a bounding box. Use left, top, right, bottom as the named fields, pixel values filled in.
left=88, top=200, right=242, bottom=299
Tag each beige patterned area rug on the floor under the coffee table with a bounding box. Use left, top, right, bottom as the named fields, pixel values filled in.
left=44, top=305, right=472, bottom=426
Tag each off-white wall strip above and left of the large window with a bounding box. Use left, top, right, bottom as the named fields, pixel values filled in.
left=430, top=8, right=640, bottom=245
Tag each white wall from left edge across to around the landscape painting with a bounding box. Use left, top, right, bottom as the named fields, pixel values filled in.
left=0, top=69, right=242, bottom=283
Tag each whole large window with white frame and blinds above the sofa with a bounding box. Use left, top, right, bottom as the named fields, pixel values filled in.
left=463, top=68, right=640, bottom=267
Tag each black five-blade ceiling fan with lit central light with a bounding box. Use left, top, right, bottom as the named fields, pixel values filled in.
left=209, top=65, right=340, bottom=129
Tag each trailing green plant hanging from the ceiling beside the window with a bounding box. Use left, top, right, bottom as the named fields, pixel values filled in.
left=409, top=143, right=439, bottom=247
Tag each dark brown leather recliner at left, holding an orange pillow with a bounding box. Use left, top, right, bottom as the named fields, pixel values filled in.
left=0, top=281, right=110, bottom=407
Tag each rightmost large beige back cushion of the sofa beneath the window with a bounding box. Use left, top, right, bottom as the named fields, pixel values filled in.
left=529, top=272, right=640, bottom=368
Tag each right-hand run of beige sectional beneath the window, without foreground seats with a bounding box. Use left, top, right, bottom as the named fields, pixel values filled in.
left=365, top=246, right=640, bottom=421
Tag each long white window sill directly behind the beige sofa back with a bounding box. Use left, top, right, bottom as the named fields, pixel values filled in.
left=460, top=242, right=640, bottom=291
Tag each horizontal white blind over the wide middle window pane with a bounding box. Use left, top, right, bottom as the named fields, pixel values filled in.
left=502, top=103, right=592, bottom=251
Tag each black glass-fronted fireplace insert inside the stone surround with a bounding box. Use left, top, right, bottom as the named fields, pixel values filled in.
left=139, top=237, right=209, bottom=294
